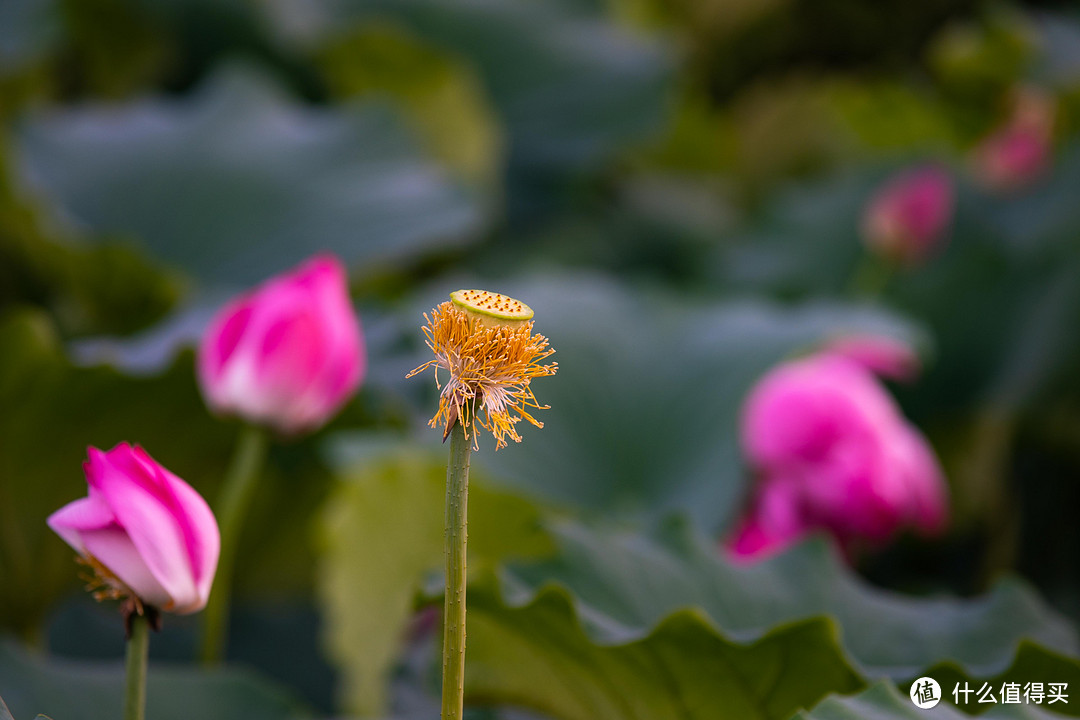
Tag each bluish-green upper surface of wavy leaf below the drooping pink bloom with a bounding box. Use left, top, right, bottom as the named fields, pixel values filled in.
left=494, top=522, right=1080, bottom=681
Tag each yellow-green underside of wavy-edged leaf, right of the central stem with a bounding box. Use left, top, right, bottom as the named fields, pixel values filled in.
left=465, top=587, right=863, bottom=720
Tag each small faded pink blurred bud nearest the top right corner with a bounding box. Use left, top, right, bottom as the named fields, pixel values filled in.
left=973, top=89, right=1056, bottom=193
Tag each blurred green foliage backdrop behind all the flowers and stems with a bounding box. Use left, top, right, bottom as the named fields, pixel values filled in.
left=0, top=0, right=1080, bottom=720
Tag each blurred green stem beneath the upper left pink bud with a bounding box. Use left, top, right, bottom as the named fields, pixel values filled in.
left=200, top=425, right=268, bottom=665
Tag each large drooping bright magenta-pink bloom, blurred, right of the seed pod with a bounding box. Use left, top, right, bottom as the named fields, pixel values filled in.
left=731, top=352, right=947, bottom=556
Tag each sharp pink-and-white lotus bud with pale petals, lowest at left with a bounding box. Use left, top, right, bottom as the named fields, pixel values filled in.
left=48, top=443, right=221, bottom=614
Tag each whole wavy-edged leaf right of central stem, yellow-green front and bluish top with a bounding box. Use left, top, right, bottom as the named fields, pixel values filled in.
left=467, top=521, right=1080, bottom=720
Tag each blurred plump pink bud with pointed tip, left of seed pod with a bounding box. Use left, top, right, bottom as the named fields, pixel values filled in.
left=199, top=256, right=366, bottom=433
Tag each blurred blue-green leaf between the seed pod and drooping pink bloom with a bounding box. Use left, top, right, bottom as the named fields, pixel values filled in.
left=399, top=274, right=920, bottom=531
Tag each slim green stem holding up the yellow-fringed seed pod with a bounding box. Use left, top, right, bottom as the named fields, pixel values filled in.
left=443, top=421, right=472, bottom=720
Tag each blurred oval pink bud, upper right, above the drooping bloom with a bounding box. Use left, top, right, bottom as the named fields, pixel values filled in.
left=863, top=165, right=954, bottom=266
